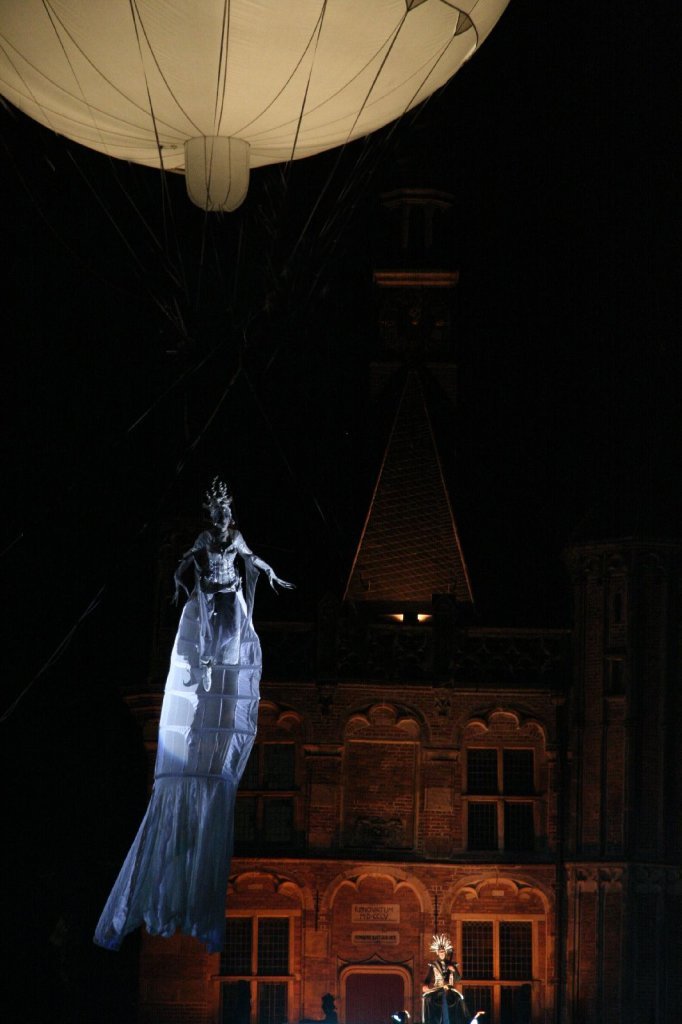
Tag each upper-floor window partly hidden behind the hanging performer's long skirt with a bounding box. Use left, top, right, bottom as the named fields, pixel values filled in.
left=235, top=743, right=297, bottom=847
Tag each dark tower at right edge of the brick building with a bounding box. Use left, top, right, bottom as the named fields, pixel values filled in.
left=565, top=539, right=682, bottom=1024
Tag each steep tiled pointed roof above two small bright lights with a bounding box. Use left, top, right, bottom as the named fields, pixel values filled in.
left=344, top=370, right=473, bottom=604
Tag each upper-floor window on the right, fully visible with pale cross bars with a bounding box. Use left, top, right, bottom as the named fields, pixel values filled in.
left=465, top=746, right=537, bottom=851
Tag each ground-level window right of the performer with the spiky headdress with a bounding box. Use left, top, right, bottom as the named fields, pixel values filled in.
left=461, top=921, right=532, bottom=1024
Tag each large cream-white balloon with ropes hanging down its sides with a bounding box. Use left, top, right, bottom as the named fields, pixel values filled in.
left=0, top=0, right=508, bottom=210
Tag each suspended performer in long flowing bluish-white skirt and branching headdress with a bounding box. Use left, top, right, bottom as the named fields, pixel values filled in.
left=94, top=477, right=293, bottom=952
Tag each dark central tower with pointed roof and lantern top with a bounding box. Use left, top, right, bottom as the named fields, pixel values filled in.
left=344, top=188, right=473, bottom=621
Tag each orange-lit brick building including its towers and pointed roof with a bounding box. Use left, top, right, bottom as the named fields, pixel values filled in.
left=123, top=191, right=682, bottom=1024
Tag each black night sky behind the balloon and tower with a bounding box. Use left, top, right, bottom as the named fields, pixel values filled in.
left=0, top=0, right=680, bottom=1015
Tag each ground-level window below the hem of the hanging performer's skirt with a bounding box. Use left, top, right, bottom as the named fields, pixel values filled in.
left=220, top=916, right=291, bottom=1024
